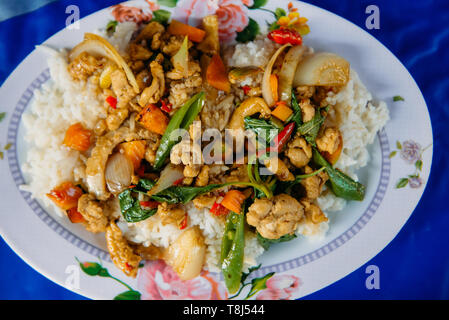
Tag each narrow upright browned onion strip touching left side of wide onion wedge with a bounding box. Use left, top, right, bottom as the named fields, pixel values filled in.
left=278, top=46, right=306, bottom=106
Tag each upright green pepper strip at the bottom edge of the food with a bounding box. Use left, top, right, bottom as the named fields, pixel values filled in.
left=220, top=209, right=246, bottom=293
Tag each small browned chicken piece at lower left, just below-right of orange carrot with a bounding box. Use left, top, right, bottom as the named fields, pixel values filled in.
left=78, top=194, right=108, bottom=233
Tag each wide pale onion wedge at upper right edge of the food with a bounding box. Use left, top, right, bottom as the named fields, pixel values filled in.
left=293, top=52, right=350, bottom=87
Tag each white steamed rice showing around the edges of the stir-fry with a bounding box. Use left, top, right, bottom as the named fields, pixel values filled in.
left=22, top=23, right=389, bottom=271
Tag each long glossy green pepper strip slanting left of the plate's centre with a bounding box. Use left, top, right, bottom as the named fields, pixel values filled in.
left=154, top=92, right=204, bottom=170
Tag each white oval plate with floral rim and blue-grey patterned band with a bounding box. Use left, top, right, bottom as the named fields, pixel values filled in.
left=0, top=0, right=432, bottom=299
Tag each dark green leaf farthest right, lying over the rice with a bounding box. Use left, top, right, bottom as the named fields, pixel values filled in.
left=313, top=148, right=365, bottom=201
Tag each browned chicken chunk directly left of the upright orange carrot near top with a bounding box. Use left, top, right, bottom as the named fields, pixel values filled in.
left=168, top=72, right=203, bottom=112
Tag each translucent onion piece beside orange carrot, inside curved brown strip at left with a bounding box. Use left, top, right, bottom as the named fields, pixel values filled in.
left=105, top=152, right=134, bottom=193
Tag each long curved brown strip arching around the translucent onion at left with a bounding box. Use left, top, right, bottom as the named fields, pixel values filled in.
left=86, top=126, right=159, bottom=200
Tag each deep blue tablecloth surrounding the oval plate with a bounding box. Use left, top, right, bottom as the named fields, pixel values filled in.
left=0, top=0, right=449, bottom=299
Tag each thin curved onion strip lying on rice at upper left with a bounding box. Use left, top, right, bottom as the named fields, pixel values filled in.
left=69, top=33, right=140, bottom=93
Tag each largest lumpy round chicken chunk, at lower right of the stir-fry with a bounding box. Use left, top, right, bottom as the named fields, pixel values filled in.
left=246, top=194, right=304, bottom=239
